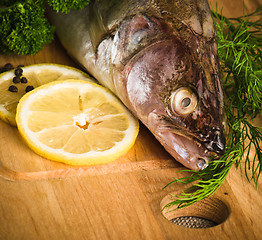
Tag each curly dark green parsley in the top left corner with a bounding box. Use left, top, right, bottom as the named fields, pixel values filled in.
left=0, top=0, right=89, bottom=55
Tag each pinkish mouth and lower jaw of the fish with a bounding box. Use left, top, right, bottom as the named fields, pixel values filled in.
left=156, top=131, right=215, bottom=171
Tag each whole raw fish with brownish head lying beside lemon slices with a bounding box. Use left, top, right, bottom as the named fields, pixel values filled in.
left=48, top=0, right=225, bottom=171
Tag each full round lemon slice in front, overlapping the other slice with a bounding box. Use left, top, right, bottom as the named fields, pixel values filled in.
left=16, top=80, right=139, bottom=165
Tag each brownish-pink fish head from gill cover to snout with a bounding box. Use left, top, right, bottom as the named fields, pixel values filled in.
left=115, top=10, right=225, bottom=171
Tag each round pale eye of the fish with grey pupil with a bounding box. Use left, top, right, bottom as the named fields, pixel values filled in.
left=171, top=87, right=197, bottom=115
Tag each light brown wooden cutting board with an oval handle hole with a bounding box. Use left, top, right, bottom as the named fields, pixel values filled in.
left=0, top=0, right=262, bottom=240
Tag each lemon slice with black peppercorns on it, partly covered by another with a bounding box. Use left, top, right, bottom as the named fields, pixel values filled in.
left=0, top=63, right=92, bottom=126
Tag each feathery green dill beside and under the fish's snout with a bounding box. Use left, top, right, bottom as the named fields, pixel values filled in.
left=165, top=6, right=262, bottom=209
